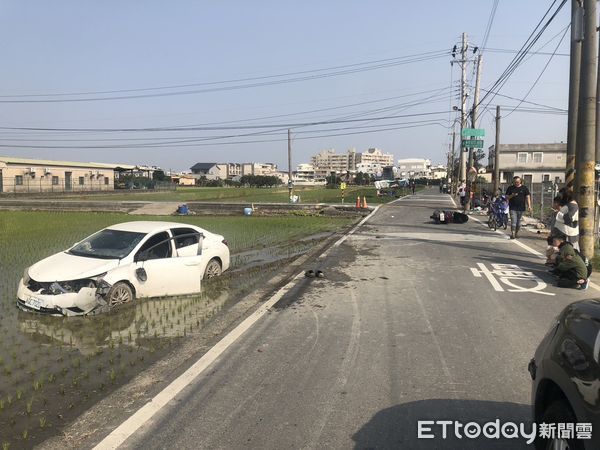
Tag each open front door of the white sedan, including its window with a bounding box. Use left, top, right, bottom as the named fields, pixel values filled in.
left=134, top=231, right=200, bottom=297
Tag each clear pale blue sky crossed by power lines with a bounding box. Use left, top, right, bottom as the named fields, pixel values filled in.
left=0, top=0, right=570, bottom=170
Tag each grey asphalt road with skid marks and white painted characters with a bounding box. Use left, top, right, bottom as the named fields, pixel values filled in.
left=116, top=190, right=597, bottom=449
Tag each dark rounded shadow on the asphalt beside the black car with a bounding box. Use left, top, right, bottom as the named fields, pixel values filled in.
left=352, top=399, right=531, bottom=449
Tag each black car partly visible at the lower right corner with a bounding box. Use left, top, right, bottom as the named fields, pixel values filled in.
left=529, top=300, right=600, bottom=449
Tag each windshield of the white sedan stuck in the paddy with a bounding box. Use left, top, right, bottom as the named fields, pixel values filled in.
left=67, top=229, right=146, bottom=259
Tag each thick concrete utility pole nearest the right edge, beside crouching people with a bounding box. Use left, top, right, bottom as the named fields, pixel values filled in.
left=575, top=0, right=598, bottom=259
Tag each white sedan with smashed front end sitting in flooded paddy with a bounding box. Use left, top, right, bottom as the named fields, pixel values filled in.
left=17, top=221, right=229, bottom=316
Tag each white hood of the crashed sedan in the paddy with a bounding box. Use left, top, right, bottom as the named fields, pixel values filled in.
left=29, top=252, right=119, bottom=282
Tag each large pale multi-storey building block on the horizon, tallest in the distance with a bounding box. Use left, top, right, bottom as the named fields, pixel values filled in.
left=311, top=148, right=394, bottom=175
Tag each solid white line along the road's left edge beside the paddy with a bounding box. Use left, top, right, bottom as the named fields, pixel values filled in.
left=94, top=206, right=379, bottom=450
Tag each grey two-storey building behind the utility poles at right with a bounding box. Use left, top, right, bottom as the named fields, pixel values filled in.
left=488, top=142, right=567, bottom=186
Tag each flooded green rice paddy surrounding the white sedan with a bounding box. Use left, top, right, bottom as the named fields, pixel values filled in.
left=0, top=211, right=354, bottom=449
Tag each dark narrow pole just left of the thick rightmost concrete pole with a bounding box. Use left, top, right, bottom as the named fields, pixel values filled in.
left=565, top=0, right=583, bottom=186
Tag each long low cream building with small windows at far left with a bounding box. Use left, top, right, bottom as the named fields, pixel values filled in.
left=0, top=156, right=116, bottom=193
